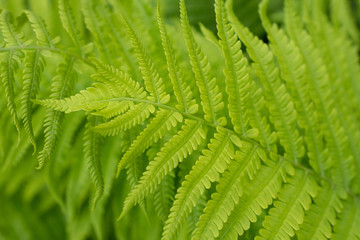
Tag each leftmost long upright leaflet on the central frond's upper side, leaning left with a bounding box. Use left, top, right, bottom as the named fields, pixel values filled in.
left=123, top=15, right=170, bottom=104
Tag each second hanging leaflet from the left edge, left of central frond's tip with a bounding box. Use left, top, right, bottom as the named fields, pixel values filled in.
left=21, top=50, right=44, bottom=153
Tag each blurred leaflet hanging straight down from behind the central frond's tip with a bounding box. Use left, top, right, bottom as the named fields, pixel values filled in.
left=84, top=115, right=104, bottom=206
